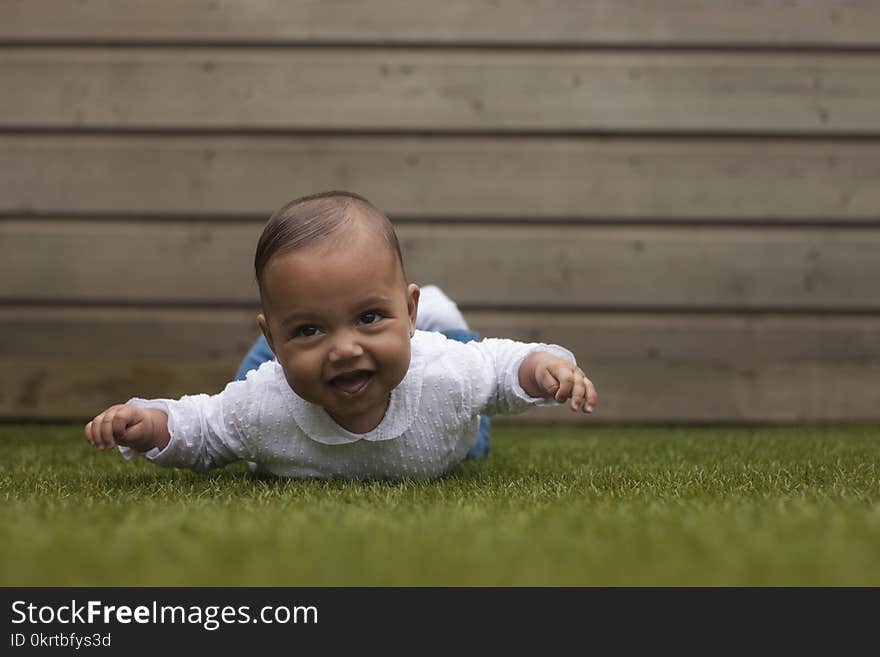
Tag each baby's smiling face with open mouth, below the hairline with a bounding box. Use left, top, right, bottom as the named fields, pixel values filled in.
left=259, top=229, right=419, bottom=433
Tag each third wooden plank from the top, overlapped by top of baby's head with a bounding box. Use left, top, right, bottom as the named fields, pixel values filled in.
left=0, top=135, right=880, bottom=222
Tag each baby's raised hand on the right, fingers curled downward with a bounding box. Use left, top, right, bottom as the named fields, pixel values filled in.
left=520, top=352, right=598, bottom=413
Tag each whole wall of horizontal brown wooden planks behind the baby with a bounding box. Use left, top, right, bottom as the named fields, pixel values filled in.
left=0, top=0, right=880, bottom=422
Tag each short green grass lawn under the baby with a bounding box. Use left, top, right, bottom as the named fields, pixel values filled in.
left=0, top=425, right=880, bottom=586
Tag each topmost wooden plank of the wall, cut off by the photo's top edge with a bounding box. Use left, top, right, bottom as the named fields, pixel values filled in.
left=0, top=0, right=880, bottom=47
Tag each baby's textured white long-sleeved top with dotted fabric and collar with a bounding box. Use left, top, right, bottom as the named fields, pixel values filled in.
left=119, top=331, right=575, bottom=479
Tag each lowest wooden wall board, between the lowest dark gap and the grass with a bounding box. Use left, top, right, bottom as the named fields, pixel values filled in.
left=0, top=308, right=880, bottom=422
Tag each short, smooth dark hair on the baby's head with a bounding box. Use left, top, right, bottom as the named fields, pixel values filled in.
left=254, top=190, right=406, bottom=295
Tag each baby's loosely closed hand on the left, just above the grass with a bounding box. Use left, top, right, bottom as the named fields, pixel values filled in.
left=85, top=404, right=168, bottom=452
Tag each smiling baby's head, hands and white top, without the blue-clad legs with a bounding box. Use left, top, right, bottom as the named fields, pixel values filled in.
left=85, top=192, right=596, bottom=479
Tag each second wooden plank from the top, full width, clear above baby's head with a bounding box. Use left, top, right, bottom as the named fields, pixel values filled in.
left=0, top=48, right=880, bottom=134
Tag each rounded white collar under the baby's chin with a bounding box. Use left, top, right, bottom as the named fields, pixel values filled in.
left=286, top=331, right=425, bottom=445
